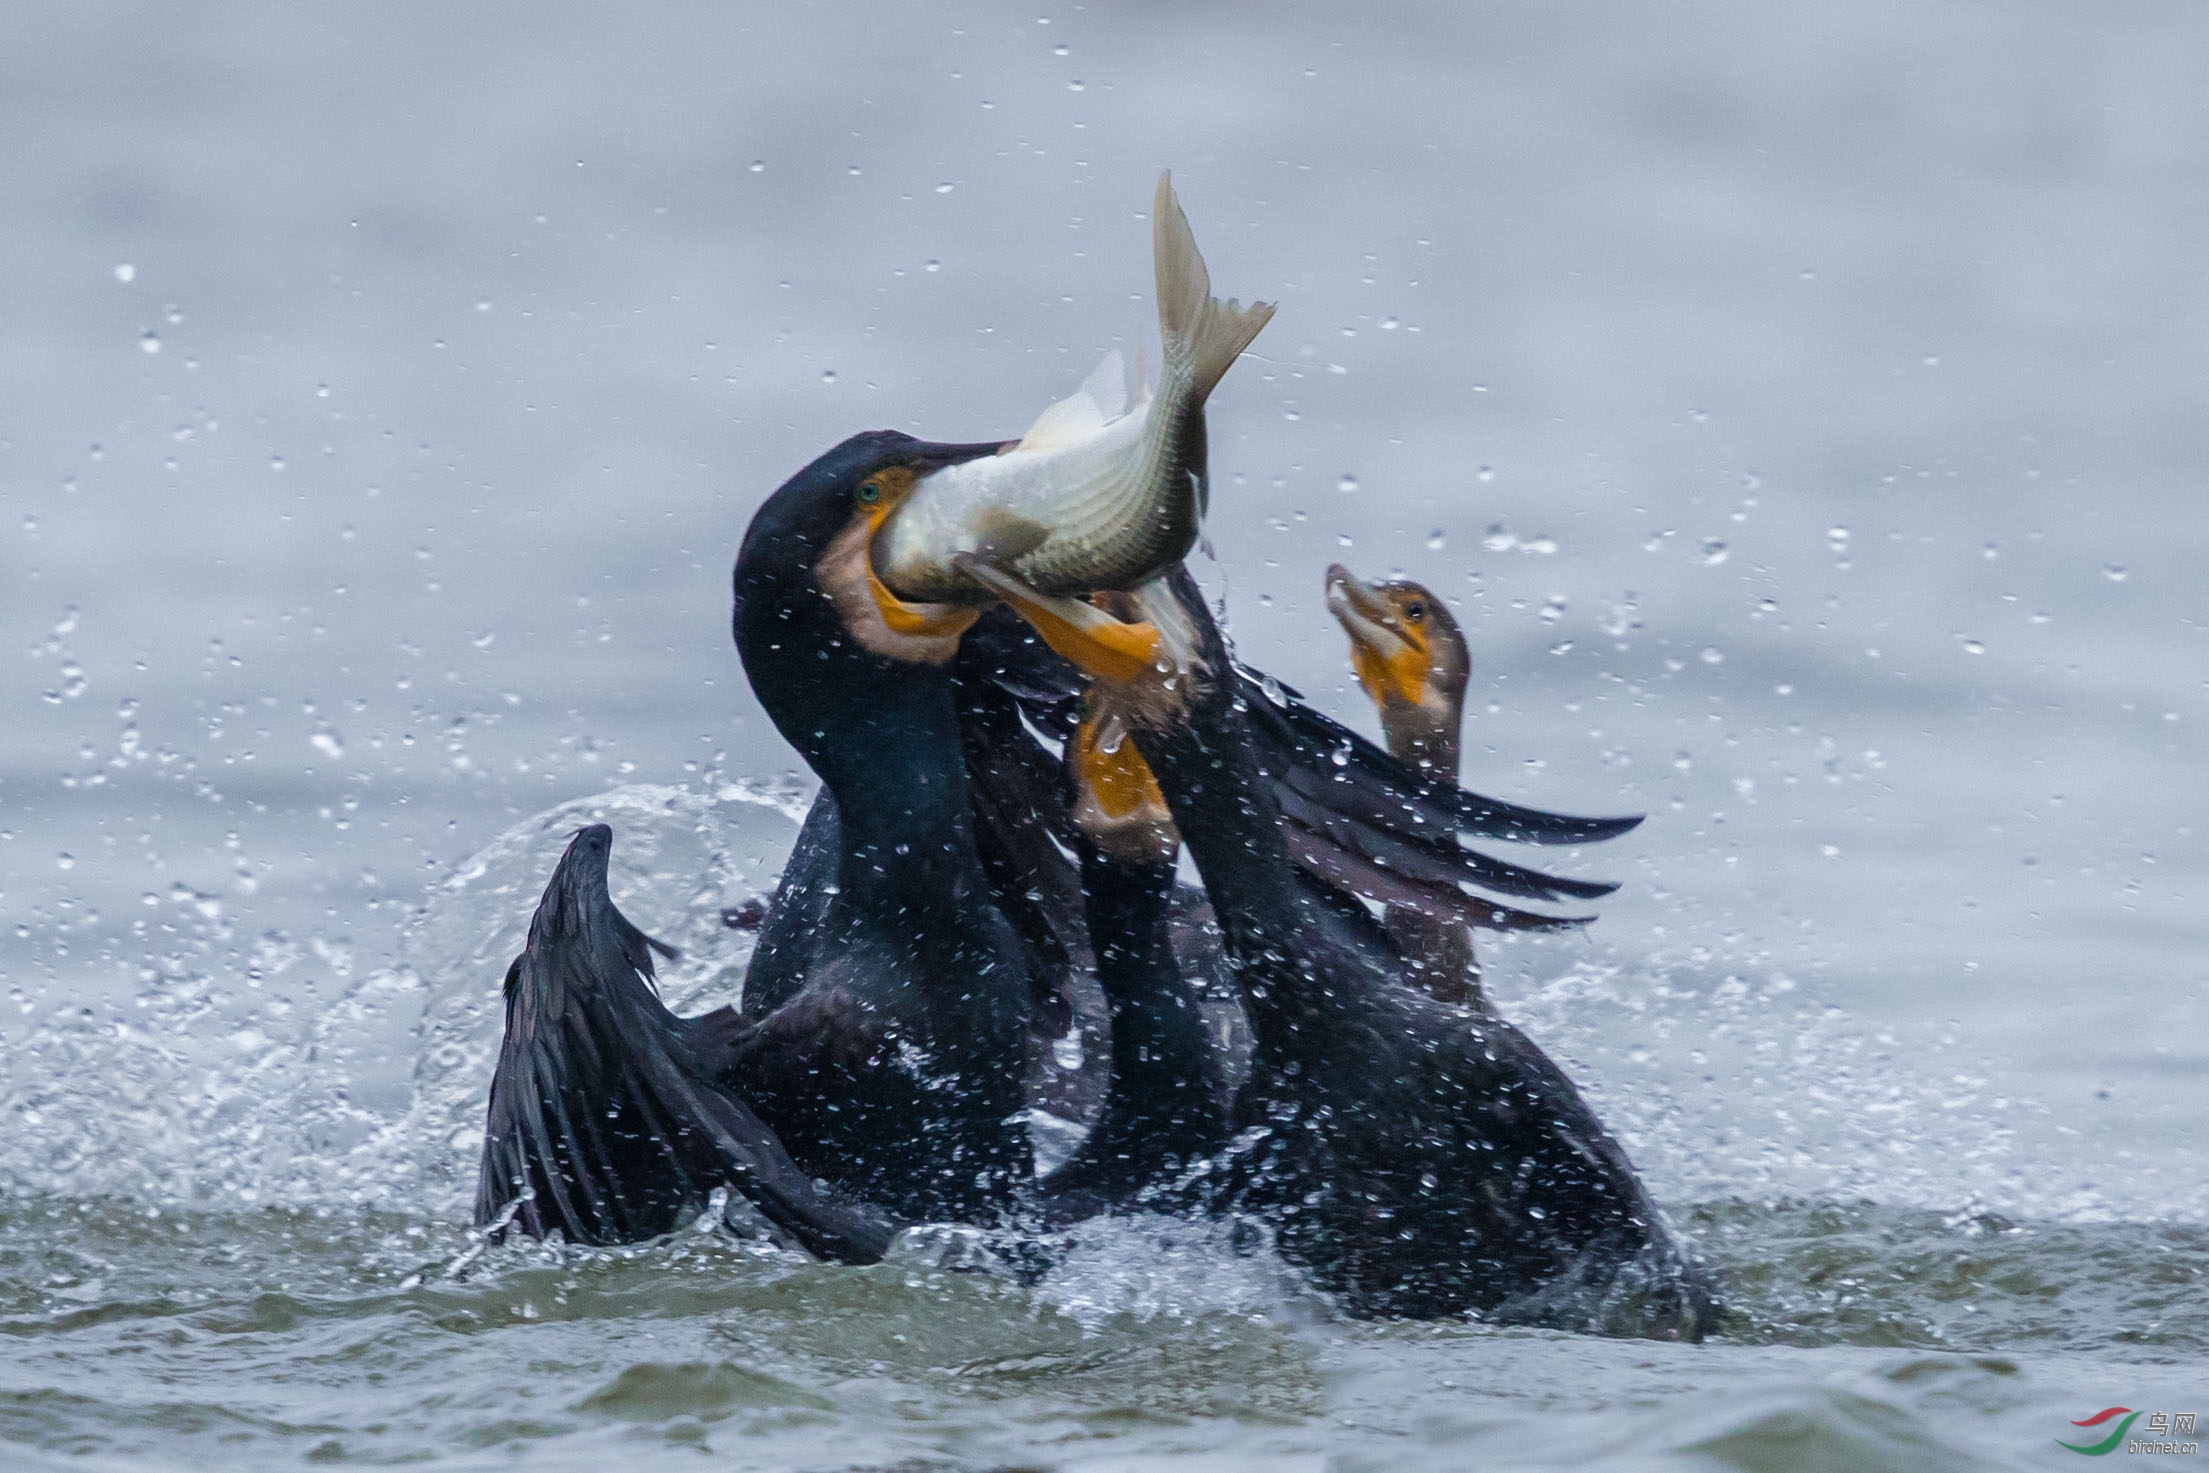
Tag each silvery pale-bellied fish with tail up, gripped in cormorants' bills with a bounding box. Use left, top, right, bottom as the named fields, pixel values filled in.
left=873, top=174, right=1272, bottom=605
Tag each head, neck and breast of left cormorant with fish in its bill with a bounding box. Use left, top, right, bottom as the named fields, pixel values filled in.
left=725, top=431, right=1034, bottom=1221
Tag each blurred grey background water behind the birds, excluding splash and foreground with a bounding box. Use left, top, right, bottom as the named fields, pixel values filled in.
left=0, top=4, right=2209, bottom=1458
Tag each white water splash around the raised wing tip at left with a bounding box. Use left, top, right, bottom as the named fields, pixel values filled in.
left=0, top=784, right=797, bottom=1217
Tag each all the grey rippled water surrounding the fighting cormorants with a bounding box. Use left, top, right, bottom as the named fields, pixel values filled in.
left=0, top=2, right=2209, bottom=1471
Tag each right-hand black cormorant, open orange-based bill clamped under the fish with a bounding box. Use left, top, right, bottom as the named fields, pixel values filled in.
left=968, top=559, right=1716, bottom=1338
